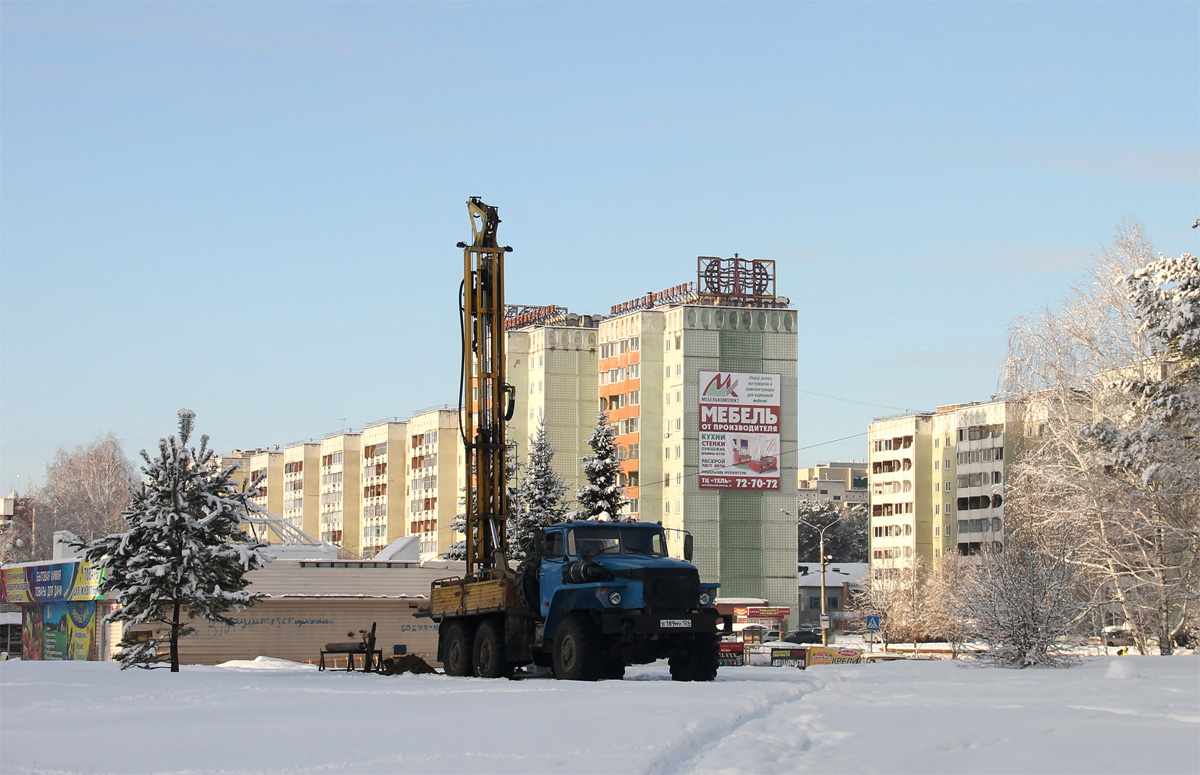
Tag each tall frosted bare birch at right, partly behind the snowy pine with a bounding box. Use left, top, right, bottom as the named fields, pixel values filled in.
left=1006, top=223, right=1200, bottom=654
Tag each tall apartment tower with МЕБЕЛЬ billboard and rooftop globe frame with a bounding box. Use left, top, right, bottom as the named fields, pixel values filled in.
left=600, top=257, right=797, bottom=620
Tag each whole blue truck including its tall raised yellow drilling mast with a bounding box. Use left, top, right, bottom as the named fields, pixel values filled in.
left=427, top=197, right=732, bottom=680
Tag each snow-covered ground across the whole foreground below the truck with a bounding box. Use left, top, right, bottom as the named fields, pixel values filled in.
left=0, top=655, right=1200, bottom=775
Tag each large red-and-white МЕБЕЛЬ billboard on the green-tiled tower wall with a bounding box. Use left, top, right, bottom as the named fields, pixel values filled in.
left=698, top=372, right=780, bottom=489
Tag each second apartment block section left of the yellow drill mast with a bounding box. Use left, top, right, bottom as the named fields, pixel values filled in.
left=360, top=417, right=409, bottom=558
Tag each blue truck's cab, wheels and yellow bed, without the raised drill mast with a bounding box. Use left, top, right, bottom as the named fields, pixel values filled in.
left=430, top=522, right=732, bottom=681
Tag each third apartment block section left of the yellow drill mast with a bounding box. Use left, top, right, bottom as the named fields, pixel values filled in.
left=320, top=431, right=362, bottom=557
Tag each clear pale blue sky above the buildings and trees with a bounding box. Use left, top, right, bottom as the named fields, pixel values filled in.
left=0, top=1, right=1200, bottom=492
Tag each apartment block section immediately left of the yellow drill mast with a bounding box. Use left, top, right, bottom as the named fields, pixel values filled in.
left=404, top=407, right=463, bottom=559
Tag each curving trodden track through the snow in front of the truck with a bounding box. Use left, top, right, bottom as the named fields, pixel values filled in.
left=644, top=679, right=824, bottom=775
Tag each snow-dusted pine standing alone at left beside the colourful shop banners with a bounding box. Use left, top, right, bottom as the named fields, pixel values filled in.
left=84, top=409, right=269, bottom=673
